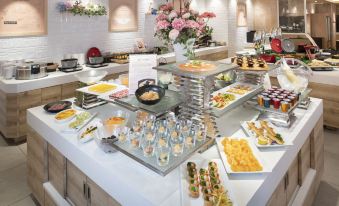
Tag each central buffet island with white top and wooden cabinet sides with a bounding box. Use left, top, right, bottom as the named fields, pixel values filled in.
left=27, top=98, right=323, bottom=205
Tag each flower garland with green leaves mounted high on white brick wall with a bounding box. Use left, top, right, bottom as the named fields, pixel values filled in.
left=57, top=1, right=107, bottom=17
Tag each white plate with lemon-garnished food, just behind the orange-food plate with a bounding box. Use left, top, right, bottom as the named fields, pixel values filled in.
left=241, top=121, right=293, bottom=148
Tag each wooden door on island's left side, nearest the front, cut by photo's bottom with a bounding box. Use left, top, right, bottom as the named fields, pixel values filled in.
left=87, top=178, right=120, bottom=206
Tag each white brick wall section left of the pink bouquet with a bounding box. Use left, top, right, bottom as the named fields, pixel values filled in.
left=0, top=0, right=148, bottom=60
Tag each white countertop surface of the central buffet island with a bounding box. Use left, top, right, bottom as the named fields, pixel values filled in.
left=27, top=98, right=323, bottom=206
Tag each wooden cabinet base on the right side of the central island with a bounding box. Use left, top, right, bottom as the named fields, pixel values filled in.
left=267, top=117, right=324, bottom=206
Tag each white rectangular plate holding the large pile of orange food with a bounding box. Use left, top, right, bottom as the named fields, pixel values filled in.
left=215, top=137, right=271, bottom=174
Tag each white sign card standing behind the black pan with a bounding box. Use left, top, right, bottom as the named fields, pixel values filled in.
left=129, top=54, right=157, bottom=94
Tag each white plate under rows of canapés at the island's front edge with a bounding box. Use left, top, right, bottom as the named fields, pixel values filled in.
left=180, top=159, right=237, bottom=206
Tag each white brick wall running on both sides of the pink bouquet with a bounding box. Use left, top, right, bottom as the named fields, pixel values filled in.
left=0, top=0, right=253, bottom=61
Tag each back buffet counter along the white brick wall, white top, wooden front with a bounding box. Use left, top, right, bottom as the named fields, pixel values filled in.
left=0, top=46, right=228, bottom=142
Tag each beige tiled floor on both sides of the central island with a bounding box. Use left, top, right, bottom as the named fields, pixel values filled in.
left=0, top=130, right=339, bottom=206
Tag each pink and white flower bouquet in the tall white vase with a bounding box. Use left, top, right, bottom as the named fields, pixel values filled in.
left=154, top=3, right=216, bottom=59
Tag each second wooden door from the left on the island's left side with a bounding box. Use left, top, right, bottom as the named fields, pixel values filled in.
left=48, top=144, right=66, bottom=197
